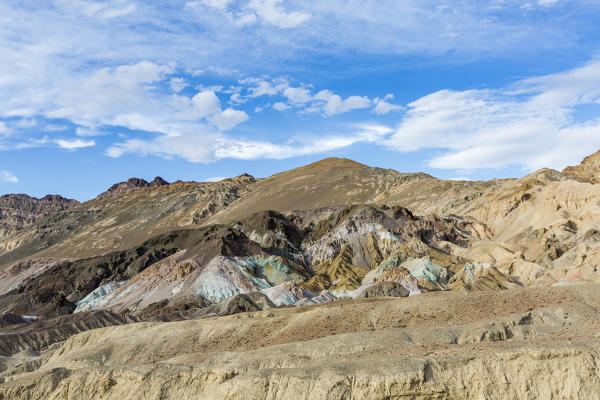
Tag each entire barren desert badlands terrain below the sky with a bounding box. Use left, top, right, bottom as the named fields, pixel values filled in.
left=0, top=153, right=600, bottom=399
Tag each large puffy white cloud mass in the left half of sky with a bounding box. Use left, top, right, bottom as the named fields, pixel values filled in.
left=0, top=57, right=248, bottom=143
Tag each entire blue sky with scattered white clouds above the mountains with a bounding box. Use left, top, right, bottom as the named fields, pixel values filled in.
left=0, top=0, right=600, bottom=200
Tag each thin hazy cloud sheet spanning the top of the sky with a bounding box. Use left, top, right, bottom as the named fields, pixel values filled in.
left=0, top=0, right=598, bottom=100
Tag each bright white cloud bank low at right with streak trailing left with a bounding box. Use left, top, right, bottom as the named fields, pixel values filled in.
left=103, top=61, right=600, bottom=168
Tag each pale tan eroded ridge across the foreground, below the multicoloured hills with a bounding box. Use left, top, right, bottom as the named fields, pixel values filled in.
left=0, top=285, right=600, bottom=400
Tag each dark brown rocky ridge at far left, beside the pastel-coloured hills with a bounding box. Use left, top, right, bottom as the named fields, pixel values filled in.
left=0, top=230, right=208, bottom=317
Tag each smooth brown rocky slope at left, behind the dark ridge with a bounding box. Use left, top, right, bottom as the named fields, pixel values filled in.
left=0, top=175, right=256, bottom=265
